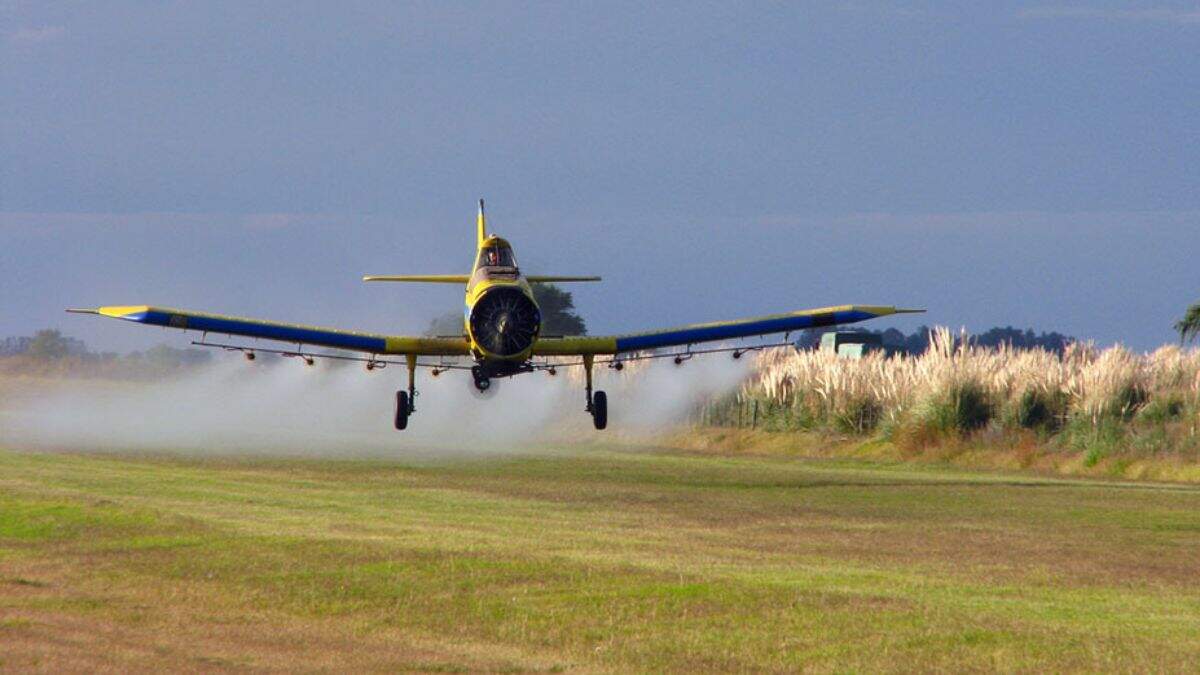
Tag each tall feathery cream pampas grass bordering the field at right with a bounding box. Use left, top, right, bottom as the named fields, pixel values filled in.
left=707, top=328, right=1200, bottom=448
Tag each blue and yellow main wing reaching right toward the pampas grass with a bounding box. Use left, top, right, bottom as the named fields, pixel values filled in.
left=533, top=305, right=925, bottom=356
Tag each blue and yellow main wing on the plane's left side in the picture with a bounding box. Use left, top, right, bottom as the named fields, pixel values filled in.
left=67, top=305, right=470, bottom=357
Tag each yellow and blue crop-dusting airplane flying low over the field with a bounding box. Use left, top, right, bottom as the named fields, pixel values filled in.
left=66, top=199, right=924, bottom=430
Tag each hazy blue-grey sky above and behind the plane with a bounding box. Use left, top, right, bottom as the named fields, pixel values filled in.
left=0, top=0, right=1200, bottom=351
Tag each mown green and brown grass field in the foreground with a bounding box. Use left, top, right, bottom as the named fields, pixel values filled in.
left=0, top=448, right=1200, bottom=671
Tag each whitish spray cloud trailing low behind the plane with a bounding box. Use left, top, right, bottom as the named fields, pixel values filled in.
left=0, top=354, right=750, bottom=456
